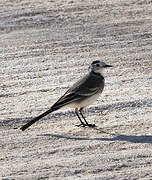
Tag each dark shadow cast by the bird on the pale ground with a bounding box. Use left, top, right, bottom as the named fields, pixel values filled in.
left=39, top=128, right=152, bottom=144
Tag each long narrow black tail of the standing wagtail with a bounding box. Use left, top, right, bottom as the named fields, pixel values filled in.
left=21, top=108, right=59, bottom=131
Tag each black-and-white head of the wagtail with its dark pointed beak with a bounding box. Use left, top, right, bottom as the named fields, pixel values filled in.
left=90, top=61, right=113, bottom=74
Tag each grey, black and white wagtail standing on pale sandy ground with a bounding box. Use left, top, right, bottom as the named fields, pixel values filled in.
left=21, top=61, right=112, bottom=131
